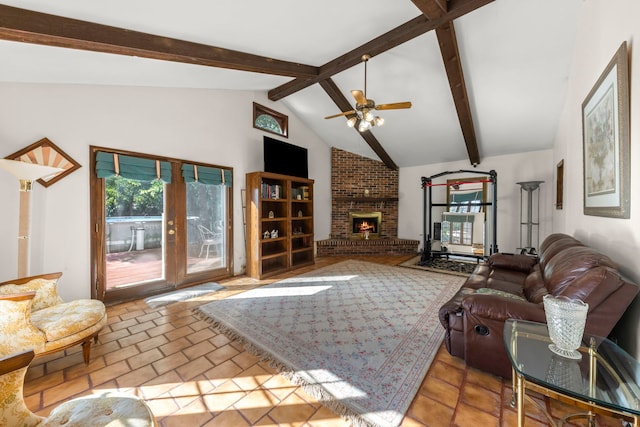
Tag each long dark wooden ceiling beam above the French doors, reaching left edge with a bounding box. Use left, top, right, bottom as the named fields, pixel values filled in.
left=0, top=5, right=318, bottom=78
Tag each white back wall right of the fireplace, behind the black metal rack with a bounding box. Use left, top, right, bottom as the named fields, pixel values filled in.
left=398, top=150, right=555, bottom=258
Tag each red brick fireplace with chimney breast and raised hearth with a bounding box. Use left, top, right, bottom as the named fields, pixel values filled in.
left=317, top=148, right=419, bottom=256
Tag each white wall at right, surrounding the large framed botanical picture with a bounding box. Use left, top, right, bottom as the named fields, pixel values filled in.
left=553, top=0, right=640, bottom=357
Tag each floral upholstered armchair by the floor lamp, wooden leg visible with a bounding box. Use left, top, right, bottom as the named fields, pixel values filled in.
left=0, top=273, right=107, bottom=364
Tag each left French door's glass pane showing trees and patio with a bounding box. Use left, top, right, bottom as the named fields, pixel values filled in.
left=104, top=176, right=165, bottom=290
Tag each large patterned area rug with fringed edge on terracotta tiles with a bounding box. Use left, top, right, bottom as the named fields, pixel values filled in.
left=196, top=260, right=463, bottom=426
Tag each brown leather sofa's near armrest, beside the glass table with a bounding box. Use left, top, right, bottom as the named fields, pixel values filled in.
left=462, top=294, right=546, bottom=323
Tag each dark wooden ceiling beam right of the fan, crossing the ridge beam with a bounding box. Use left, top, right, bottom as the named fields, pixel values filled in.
left=411, top=0, right=480, bottom=166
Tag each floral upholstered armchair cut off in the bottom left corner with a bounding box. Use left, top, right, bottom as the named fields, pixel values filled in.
left=0, top=350, right=157, bottom=427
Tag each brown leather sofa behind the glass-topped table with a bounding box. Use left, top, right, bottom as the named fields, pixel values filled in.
left=439, top=234, right=638, bottom=378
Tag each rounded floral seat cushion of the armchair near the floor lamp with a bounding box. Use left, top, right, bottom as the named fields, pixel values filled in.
left=31, top=299, right=105, bottom=342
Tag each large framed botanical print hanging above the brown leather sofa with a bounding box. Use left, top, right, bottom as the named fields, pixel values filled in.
left=582, top=42, right=631, bottom=218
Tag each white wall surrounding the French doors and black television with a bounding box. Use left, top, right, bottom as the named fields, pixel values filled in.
left=0, top=83, right=331, bottom=299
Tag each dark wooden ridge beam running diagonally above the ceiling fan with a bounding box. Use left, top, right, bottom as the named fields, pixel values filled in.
left=268, top=0, right=493, bottom=101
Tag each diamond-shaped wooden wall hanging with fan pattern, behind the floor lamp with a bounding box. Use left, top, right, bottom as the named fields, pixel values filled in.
left=6, top=138, right=80, bottom=187
